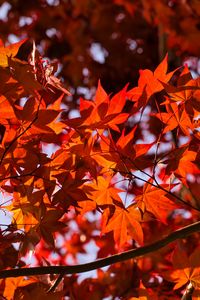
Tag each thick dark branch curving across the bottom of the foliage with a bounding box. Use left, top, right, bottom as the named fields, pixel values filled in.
left=0, top=221, right=200, bottom=278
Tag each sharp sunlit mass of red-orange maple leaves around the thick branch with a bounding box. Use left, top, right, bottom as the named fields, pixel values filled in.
left=0, top=40, right=200, bottom=300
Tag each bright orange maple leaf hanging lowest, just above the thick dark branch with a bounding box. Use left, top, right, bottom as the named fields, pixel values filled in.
left=102, top=202, right=143, bottom=248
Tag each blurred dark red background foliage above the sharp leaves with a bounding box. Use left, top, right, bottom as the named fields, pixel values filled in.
left=0, top=0, right=200, bottom=113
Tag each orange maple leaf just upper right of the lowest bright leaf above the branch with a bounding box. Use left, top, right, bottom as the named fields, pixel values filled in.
left=134, top=180, right=177, bottom=224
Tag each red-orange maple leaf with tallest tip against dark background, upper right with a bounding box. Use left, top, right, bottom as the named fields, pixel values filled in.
left=127, top=55, right=176, bottom=107
